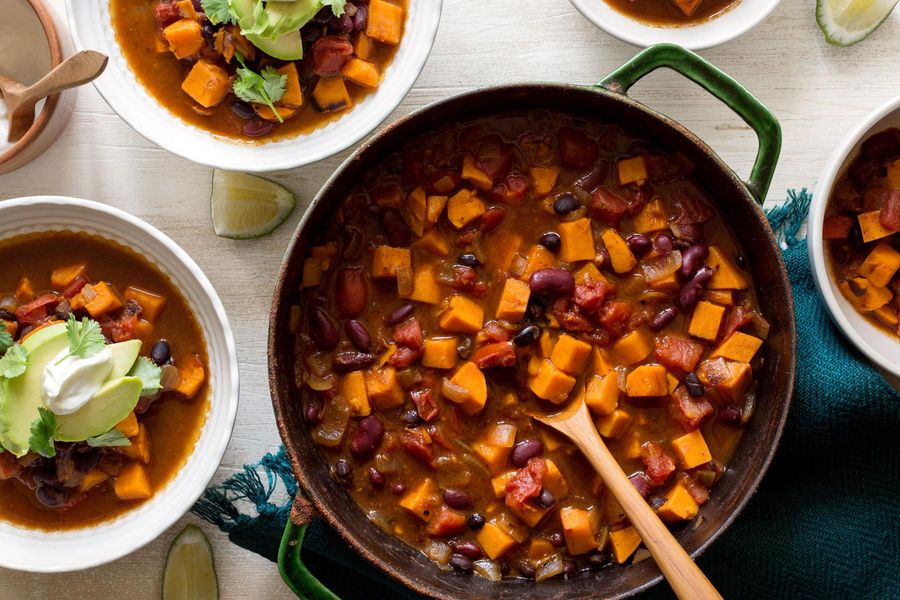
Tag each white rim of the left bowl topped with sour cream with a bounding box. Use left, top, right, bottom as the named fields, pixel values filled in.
left=0, top=195, right=240, bottom=573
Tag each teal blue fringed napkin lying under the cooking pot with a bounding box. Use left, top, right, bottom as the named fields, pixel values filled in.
left=194, top=190, right=900, bottom=600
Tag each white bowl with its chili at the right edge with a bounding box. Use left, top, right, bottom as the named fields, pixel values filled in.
left=807, top=98, right=900, bottom=377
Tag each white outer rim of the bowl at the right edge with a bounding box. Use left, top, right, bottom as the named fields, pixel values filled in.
left=807, top=97, right=900, bottom=377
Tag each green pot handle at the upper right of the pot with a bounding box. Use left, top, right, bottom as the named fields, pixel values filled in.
left=597, top=44, right=781, bottom=204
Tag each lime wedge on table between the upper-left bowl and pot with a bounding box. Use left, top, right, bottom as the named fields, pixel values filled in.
left=210, top=169, right=297, bottom=240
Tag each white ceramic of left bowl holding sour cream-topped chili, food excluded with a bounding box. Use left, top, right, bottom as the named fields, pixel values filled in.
left=0, top=196, right=238, bottom=572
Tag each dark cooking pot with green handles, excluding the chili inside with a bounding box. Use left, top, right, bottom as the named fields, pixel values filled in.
left=269, top=45, right=796, bottom=600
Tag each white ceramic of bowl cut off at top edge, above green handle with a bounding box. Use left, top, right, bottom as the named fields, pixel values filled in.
left=569, top=0, right=781, bottom=50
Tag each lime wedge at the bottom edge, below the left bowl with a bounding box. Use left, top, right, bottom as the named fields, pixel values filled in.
left=162, top=525, right=219, bottom=600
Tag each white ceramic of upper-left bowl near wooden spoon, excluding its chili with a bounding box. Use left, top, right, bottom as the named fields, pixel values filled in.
left=66, top=0, right=442, bottom=172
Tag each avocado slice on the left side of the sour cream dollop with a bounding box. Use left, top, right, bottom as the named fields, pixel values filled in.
left=0, top=323, right=69, bottom=456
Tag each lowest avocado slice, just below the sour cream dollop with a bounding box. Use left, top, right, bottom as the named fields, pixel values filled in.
left=56, top=377, right=144, bottom=442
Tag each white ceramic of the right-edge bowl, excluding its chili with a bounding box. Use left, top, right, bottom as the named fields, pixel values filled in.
left=807, top=98, right=900, bottom=378
